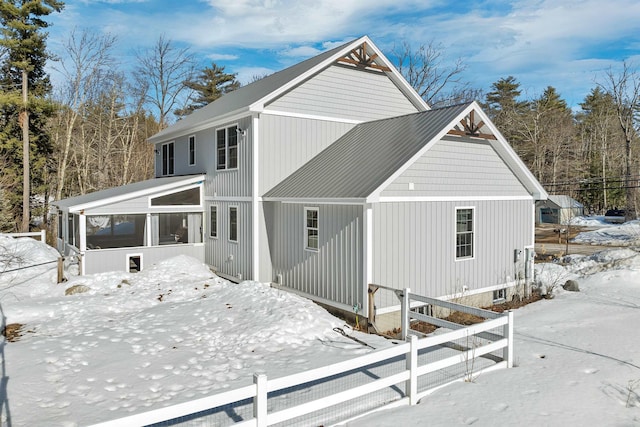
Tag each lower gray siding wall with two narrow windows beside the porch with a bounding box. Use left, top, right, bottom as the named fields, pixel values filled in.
left=205, top=201, right=253, bottom=279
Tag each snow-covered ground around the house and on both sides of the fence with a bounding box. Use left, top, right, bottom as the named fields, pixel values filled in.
left=0, top=227, right=640, bottom=427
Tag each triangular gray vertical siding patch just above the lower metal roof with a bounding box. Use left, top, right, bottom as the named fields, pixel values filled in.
left=259, top=114, right=355, bottom=195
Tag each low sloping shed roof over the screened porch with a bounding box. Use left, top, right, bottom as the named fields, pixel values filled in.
left=53, top=175, right=205, bottom=211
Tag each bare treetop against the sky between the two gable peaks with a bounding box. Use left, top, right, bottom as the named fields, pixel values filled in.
left=392, top=41, right=470, bottom=106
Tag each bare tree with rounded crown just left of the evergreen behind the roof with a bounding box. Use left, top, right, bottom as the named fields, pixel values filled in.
left=136, top=35, right=194, bottom=129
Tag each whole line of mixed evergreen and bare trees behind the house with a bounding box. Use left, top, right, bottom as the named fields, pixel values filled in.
left=0, top=0, right=640, bottom=232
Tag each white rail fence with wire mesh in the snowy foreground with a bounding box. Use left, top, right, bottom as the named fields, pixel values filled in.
left=93, top=289, right=513, bottom=427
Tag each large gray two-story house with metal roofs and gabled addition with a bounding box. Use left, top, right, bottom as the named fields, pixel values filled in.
left=58, top=37, right=546, bottom=316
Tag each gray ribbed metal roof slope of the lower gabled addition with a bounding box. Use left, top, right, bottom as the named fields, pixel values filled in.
left=264, top=103, right=471, bottom=199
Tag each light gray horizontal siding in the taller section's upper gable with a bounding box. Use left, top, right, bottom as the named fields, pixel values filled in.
left=268, top=65, right=418, bottom=121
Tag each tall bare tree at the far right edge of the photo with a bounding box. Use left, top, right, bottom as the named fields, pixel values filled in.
left=600, top=61, right=640, bottom=220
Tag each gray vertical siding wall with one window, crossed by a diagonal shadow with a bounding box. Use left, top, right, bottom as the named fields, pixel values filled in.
left=265, top=202, right=366, bottom=307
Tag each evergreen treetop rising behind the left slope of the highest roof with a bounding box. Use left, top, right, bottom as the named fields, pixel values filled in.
left=175, top=62, right=240, bottom=117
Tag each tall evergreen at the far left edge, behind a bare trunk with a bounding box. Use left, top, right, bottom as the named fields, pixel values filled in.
left=0, top=0, right=64, bottom=231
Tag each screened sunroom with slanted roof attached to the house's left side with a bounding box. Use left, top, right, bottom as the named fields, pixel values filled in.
left=54, top=175, right=205, bottom=274
